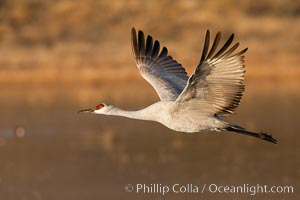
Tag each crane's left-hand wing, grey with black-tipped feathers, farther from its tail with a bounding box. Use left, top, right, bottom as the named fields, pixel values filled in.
left=131, top=28, right=188, bottom=101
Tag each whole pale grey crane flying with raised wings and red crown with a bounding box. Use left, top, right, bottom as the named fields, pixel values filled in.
left=79, top=28, right=277, bottom=144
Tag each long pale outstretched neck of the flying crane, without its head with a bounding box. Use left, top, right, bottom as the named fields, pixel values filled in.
left=108, top=105, right=161, bottom=121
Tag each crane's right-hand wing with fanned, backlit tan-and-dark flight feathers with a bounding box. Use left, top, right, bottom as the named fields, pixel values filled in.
left=176, top=31, right=247, bottom=115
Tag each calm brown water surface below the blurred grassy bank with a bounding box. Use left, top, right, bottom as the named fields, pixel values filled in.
left=0, top=83, right=300, bottom=200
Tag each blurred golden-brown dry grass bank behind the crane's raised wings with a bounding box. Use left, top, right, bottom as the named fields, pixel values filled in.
left=0, top=0, right=300, bottom=87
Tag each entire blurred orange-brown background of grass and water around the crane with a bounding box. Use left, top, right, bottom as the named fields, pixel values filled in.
left=0, top=0, right=300, bottom=200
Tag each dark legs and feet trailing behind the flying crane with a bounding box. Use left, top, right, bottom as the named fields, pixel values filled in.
left=226, top=125, right=277, bottom=144
